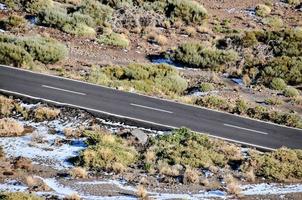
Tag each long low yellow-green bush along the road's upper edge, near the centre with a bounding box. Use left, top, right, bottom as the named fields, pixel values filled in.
left=88, top=64, right=188, bottom=95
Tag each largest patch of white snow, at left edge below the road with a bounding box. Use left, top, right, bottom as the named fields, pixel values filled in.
left=0, top=120, right=86, bottom=170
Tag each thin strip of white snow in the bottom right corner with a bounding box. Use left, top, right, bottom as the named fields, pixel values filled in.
left=241, top=183, right=302, bottom=195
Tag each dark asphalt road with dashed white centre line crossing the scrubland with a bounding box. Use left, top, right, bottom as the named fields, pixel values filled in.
left=0, top=66, right=302, bottom=150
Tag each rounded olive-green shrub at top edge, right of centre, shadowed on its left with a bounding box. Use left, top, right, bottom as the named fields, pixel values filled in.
left=166, top=0, right=207, bottom=24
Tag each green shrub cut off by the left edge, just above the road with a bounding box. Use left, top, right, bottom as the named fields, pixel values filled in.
left=0, top=42, right=33, bottom=67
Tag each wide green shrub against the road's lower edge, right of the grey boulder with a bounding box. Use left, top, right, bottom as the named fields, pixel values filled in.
left=147, top=128, right=241, bottom=168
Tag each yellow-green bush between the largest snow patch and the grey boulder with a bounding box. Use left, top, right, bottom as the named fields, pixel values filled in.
left=81, top=131, right=138, bottom=172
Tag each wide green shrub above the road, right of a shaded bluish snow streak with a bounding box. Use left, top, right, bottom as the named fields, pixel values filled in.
left=172, top=43, right=238, bottom=70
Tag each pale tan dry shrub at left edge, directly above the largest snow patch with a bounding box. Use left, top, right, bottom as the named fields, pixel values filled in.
left=0, top=118, right=24, bottom=137
